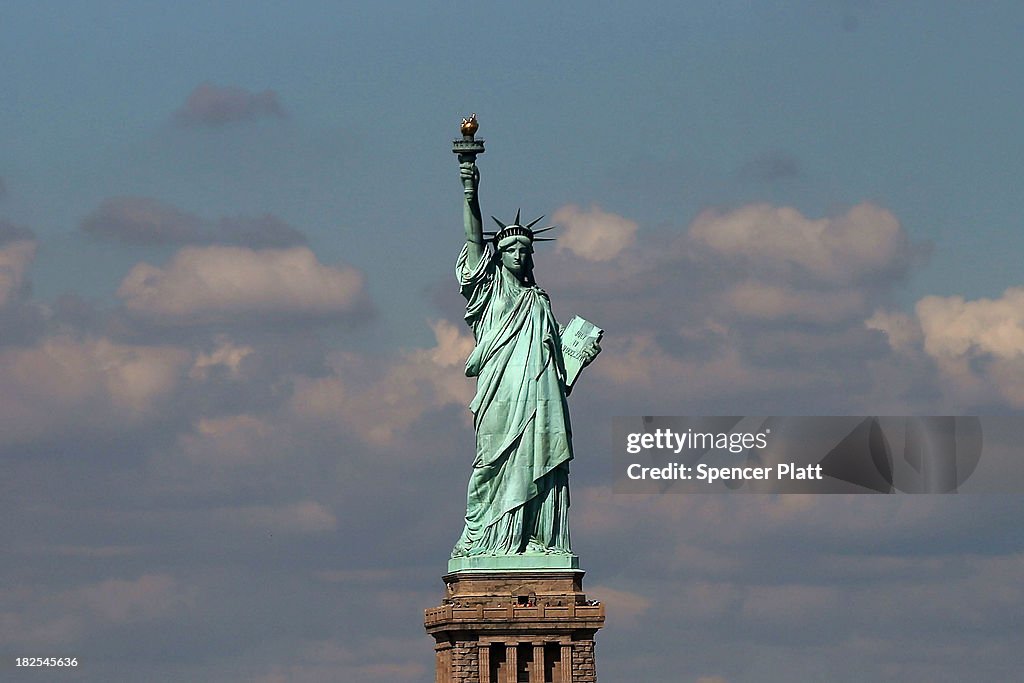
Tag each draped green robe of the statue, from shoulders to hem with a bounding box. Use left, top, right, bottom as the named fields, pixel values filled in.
left=452, top=242, right=572, bottom=557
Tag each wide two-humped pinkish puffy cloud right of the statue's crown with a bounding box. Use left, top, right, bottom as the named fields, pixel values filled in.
left=689, top=203, right=911, bottom=286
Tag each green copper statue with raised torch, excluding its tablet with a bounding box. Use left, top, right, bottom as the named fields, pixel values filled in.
left=449, top=120, right=600, bottom=571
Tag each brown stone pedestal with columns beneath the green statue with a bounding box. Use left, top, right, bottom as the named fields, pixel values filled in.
left=423, top=569, right=604, bottom=683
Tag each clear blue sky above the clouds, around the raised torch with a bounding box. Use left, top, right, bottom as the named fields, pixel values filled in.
left=2, top=3, right=1024, bottom=313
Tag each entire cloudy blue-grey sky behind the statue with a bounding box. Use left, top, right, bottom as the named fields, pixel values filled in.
left=0, top=0, right=1024, bottom=683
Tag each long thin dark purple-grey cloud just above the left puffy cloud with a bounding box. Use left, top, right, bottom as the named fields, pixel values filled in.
left=79, top=197, right=306, bottom=249
